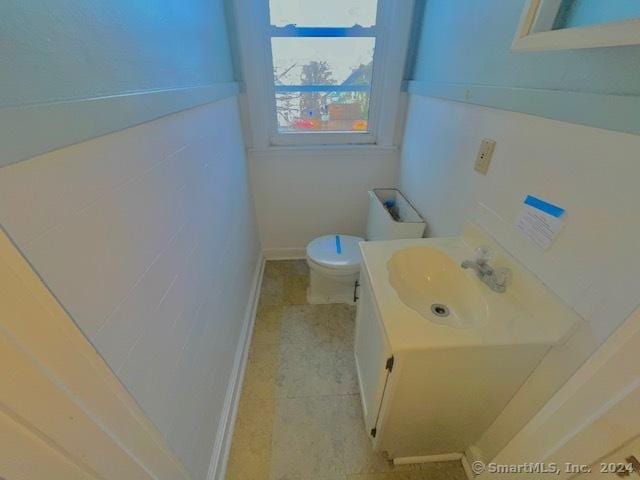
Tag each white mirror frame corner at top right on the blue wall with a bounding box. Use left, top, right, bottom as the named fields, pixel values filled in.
left=511, top=0, right=640, bottom=52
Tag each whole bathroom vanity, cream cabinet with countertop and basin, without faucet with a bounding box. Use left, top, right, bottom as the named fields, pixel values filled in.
left=355, top=232, right=580, bottom=461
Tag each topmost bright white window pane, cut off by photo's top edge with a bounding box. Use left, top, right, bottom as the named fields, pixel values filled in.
left=269, top=0, right=378, bottom=27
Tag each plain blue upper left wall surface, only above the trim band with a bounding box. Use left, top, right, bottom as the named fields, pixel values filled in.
left=0, top=0, right=233, bottom=106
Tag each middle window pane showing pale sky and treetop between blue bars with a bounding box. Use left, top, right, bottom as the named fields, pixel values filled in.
left=271, top=37, right=375, bottom=85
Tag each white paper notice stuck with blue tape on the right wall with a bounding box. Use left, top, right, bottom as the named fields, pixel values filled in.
left=516, top=195, right=564, bottom=250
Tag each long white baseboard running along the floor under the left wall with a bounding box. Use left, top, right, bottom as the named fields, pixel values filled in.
left=207, top=255, right=265, bottom=480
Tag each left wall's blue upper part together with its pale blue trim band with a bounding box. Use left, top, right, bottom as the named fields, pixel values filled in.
left=0, top=0, right=235, bottom=165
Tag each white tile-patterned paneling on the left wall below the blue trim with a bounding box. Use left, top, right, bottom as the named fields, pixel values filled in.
left=0, top=98, right=260, bottom=478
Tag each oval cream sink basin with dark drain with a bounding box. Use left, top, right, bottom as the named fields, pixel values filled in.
left=387, top=247, right=488, bottom=328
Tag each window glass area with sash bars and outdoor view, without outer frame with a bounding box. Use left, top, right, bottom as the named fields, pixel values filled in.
left=269, top=0, right=377, bottom=133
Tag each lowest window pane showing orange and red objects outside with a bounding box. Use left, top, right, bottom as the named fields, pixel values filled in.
left=276, top=91, right=369, bottom=133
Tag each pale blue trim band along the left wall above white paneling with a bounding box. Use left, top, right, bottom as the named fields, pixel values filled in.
left=0, top=82, right=239, bottom=167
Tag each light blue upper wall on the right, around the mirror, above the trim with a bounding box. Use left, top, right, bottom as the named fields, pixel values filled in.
left=412, top=0, right=640, bottom=95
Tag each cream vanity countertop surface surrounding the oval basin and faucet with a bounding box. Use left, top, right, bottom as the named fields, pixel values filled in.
left=360, top=225, right=581, bottom=351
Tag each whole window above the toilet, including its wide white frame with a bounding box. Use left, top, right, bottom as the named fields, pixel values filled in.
left=234, top=0, right=414, bottom=151
